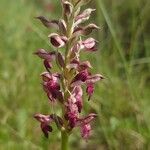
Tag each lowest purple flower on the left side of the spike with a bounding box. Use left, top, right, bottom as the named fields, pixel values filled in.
left=34, top=114, right=53, bottom=138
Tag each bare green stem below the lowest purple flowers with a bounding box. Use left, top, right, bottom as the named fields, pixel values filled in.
left=61, top=131, right=69, bottom=150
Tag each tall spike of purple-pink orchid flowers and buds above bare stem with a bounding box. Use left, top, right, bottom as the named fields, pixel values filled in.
left=34, top=0, right=103, bottom=139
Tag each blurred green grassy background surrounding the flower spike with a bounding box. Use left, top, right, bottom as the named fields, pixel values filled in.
left=0, top=0, right=150, bottom=150
